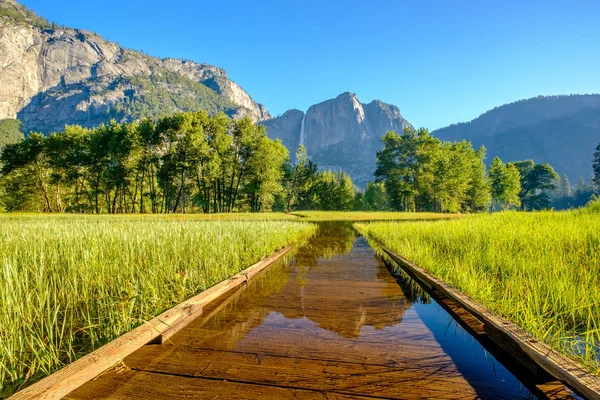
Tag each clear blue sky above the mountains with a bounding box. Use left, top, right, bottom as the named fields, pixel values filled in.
left=22, top=0, right=600, bottom=129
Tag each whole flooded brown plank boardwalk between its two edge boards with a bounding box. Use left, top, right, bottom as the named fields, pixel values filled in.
left=68, top=224, right=548, bottom=399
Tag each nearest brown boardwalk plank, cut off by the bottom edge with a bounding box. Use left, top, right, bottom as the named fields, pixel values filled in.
left=65, top=370, right=365, bottom=400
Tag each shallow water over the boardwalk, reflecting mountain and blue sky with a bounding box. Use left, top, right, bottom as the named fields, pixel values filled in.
left=165, top=223, right=552, bottom=399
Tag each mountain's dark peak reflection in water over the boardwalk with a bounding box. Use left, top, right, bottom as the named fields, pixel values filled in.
left=267, top=238, right=410, bottom=338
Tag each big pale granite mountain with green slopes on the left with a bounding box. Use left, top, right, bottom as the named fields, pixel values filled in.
left=0, top=0, right=270, bottom=133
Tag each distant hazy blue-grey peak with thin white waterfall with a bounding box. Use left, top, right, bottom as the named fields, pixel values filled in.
left=263, top=92, right=410, bottom=188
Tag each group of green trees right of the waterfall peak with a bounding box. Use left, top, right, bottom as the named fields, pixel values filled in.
left=372, top=128, right=600, bottom=212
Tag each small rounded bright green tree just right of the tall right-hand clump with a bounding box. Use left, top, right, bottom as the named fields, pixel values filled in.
left=488, top=157, right=521, bottom=209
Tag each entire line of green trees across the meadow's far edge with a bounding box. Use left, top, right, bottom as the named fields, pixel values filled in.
left=0, top=111, right=600, bottom=214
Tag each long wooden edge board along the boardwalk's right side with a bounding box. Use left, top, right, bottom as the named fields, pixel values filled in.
left=381, top=246, right=600, bottom=400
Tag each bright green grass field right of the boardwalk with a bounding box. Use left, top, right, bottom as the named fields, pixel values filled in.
left=355, top=205, right=600, bottom=375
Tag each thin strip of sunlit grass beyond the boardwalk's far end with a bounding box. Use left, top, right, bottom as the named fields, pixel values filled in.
left=290, top=211, right=464, bottom=221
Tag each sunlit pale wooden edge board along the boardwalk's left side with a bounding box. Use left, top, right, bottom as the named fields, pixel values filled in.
left=10, top=246, right=292, bottom=400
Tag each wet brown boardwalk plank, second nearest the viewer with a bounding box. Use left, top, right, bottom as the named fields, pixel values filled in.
left=124, top=346, right=494, bottom=398
